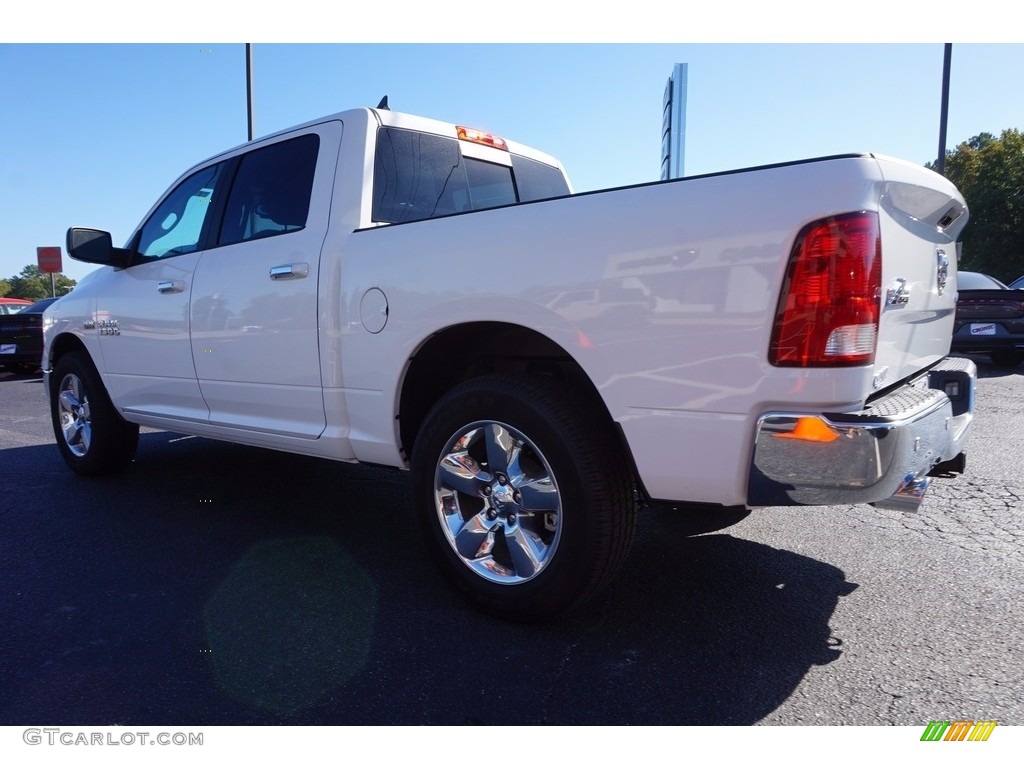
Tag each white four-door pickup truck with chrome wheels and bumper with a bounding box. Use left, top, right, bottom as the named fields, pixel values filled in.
left=42, top=103, right=976, bottom=620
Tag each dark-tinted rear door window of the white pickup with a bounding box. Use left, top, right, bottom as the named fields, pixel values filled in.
left=218, top=133, right=319, bottom=245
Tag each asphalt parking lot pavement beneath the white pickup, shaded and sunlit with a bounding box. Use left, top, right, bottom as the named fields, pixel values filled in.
left=0, top=358, right=1024, bottom=727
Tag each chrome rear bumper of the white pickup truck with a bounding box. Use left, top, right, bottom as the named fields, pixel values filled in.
left=748, top=357, right=977, bottom=509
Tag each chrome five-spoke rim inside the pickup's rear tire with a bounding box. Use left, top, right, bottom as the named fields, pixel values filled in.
left=434, top=421, right=562, bottom=585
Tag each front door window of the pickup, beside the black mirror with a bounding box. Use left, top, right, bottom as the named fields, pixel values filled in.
left=138, top=163, right=224, bottom=259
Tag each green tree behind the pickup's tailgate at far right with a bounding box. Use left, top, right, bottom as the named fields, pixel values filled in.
left=928, top=128, right=1024, bottom=283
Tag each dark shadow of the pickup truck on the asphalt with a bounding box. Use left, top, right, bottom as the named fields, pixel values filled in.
left=0, top=432, right=855, bottom=726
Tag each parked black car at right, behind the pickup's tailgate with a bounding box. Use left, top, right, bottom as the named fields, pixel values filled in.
left=952, top=272, right=1024, bottom=368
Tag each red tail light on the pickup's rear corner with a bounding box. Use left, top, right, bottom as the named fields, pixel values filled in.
left=768, top=212, right=882, bottom=368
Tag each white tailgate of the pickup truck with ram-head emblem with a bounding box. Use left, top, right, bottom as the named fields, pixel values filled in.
left=873, top=157, right=968, bottom=388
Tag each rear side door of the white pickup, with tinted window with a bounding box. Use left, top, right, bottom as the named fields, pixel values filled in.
left=190, top=121, right=342, bottom=438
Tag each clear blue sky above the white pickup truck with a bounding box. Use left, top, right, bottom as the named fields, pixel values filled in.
left=6, top=39, right=1024, bottom=286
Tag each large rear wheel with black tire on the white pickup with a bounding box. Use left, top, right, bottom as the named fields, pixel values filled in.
left=413, top=376, right=636, bottom=621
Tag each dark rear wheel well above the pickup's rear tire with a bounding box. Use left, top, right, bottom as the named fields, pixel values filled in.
left=398, top=323, right=629, bottom=459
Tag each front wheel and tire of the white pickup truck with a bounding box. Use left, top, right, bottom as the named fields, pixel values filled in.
left=49, top=351, right=138, bottom=477
